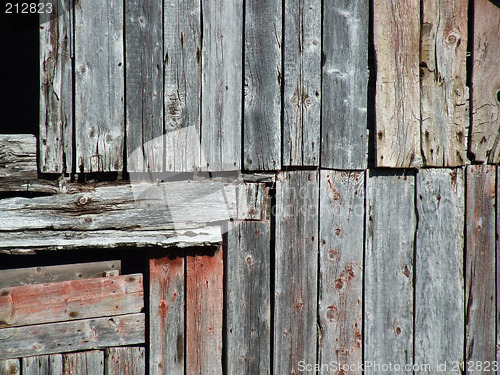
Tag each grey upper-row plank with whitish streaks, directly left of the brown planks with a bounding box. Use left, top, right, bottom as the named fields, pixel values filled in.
left=321, top=0, right=368, bottom=169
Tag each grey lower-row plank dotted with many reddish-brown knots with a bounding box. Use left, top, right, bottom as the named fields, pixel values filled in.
left=318, top=171, right=365, bottom=374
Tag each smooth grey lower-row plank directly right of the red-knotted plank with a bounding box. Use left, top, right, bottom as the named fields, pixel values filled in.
left=364, top=171, right=417, bottom=374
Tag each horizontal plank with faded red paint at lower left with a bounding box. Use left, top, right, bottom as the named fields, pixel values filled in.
left=0, top=274, right=144, bottom=328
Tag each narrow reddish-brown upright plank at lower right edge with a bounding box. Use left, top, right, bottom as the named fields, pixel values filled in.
left=465, top=165, right=496, bottom=363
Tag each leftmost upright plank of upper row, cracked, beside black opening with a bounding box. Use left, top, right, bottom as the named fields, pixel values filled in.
left=39, top=0, right=73, bottom=173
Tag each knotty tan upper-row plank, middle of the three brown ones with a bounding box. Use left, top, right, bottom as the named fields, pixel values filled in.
left=420, top=0, right=468, bottom=167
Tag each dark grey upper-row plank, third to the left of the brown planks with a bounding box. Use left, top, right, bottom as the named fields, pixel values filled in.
left=243, top=0, right=283, bottom=171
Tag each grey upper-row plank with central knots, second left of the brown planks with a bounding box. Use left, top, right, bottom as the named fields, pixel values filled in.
left=282, top=0, right=321, bottom=166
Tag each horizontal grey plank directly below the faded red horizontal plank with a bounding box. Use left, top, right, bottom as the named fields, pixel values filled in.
left=0, top=314, right=145, bottom=359
